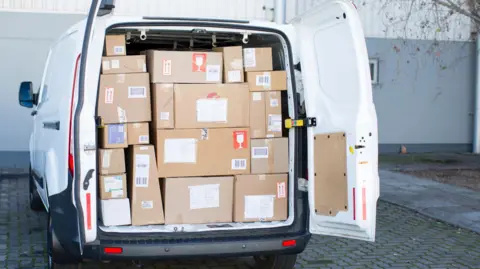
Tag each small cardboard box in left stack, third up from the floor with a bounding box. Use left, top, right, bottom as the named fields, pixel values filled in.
left=98, top=149, right=125, bottom=175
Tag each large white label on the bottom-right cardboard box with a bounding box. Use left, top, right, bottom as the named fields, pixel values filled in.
left=244, top=195, right=275, bottom=220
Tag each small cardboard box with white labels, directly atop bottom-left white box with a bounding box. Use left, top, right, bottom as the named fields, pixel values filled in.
left=98, top=174, right=127, bottom=200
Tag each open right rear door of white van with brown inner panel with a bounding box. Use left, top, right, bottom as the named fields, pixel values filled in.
left=292, top=0, right=379, bottom=241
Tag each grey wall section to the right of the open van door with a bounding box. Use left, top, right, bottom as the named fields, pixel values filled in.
left=367, top=38, right=475, bottom=152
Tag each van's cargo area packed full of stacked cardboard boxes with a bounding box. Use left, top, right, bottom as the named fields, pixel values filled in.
left=97, top=27, right=298, bottom=234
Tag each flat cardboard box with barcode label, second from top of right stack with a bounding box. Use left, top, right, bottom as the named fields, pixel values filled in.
left=247, top=71, right=287, bottom=92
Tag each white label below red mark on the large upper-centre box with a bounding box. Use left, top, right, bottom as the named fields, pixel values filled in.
left=197, top=98, right=228, bottom=122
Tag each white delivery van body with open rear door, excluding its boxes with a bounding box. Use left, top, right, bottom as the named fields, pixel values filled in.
left=19, top=0, right=379, bottom=269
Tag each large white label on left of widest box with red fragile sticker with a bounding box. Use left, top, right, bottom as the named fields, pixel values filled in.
left=163, top=138, right=197, bottom=163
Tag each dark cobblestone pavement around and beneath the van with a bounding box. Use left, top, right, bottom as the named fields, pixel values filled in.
left=0, top=176, right=480, bottom=269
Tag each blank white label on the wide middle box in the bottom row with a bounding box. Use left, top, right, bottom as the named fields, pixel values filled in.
left=188, top=184, right=220, bottom=209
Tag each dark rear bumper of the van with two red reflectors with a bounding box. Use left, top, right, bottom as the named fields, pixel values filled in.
left=83, top=234, right=311, bottom=261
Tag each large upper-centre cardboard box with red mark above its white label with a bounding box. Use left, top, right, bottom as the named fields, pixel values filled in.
left=174, top=84, right=250, bottom=129
